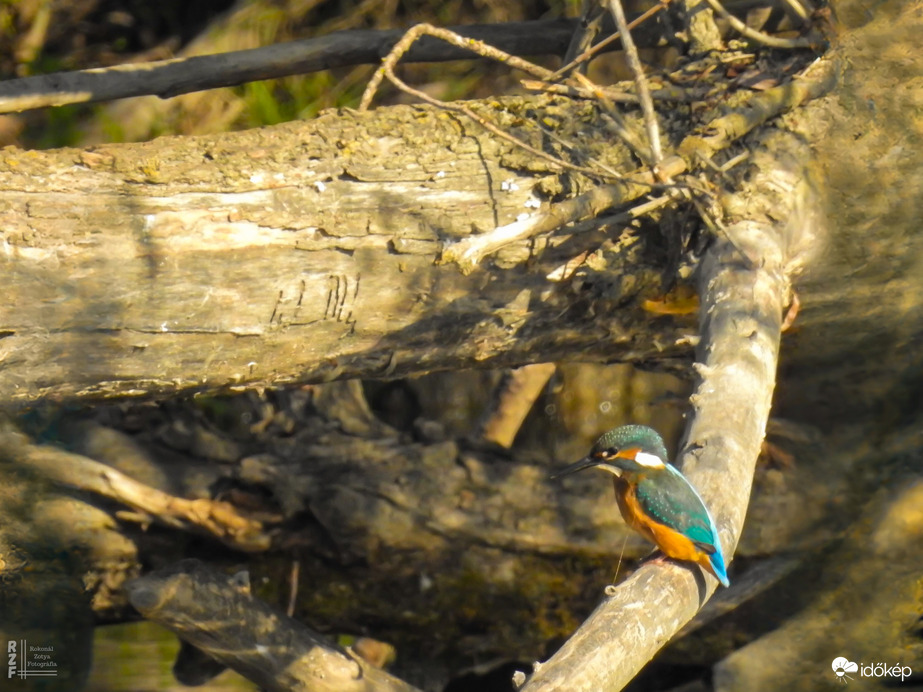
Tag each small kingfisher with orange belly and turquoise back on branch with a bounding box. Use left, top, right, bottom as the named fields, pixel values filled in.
left=552, top=425, right=729, bottom=586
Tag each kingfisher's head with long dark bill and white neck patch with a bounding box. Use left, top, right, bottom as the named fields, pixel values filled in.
left=552, top=425, right=667, bottom=478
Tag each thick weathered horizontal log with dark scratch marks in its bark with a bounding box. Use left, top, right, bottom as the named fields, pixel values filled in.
left=0, top=93, right=689, bottom=402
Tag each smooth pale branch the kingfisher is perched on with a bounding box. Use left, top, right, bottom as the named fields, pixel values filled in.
left=522, top=127, right=817, bottom=692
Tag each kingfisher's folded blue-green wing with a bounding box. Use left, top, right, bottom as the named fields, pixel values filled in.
left=635, top=464, right=721, bottom=555
